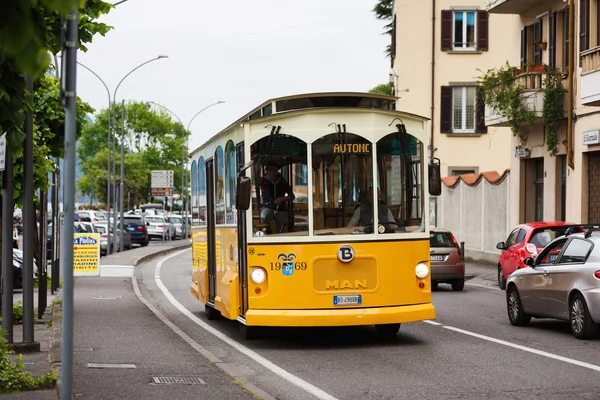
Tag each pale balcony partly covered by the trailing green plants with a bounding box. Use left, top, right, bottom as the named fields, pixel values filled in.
left=485, top=72, right=567, bottom=126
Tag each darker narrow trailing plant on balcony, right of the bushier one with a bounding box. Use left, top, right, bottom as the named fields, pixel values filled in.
left=542, top=68, right=567, bottom=157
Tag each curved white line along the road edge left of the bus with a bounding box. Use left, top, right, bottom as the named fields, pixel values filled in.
left=154, top=249, right=338, bottom=400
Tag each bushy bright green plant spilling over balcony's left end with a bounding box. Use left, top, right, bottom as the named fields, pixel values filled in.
left=477, top=61, right=535, bottom=145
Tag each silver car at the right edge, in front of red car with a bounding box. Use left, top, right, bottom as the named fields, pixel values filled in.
left=506, top=226, right=600, bottom=339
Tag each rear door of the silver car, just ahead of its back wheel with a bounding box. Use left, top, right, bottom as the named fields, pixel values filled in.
left=543, top=237, right=593, bottom=320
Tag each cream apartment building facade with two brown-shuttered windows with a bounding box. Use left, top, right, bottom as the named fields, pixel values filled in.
left=390, top=0, right=520, bottom=176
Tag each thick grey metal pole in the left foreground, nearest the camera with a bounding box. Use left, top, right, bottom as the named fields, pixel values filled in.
left=60, top=8, right=79, bottom=400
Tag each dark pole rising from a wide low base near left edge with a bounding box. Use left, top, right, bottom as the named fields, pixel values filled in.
left=22, top=77, right=36, bottom=343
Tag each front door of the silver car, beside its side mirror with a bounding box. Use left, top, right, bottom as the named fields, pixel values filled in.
left=517, top=237, right=568, bottom=316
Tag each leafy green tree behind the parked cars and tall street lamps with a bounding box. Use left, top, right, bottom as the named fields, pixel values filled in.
left=78, top=103, right=189, bottom=204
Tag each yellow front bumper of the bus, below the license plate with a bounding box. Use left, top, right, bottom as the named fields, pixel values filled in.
left=245, top=303, right=435, bottom=326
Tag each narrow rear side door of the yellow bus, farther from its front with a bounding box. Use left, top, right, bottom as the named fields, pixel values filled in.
left=206, top=158, right=217, bottom=304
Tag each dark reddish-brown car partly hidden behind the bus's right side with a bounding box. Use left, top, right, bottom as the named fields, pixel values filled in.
left=429, top=228, right=465, bottom=292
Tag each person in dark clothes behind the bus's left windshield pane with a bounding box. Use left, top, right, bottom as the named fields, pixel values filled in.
left=259, top=161, right=295, bottom=233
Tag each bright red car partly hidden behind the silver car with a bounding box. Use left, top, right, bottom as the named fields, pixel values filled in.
left=496, top=222, right=581, bottom=290
